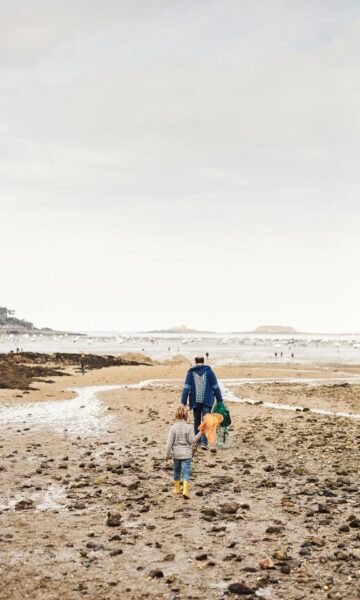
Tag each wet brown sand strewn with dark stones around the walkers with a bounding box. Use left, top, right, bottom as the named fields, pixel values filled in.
left=0, top=364, right=360, bottom=600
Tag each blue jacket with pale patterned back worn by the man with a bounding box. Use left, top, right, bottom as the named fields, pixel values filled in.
left=181, top=365, right=222, bottom=410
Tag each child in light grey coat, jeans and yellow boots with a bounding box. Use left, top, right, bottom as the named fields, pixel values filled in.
left=165, top=406, right=201, bottom=499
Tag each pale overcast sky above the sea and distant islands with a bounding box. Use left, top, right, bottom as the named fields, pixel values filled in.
left=0, top=0, right=360, bottom=332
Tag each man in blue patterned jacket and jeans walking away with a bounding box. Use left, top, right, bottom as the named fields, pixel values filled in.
left=181, top=356, right=222, bottom=450
